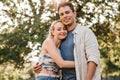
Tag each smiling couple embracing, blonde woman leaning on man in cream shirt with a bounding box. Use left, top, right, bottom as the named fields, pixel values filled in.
left=34, top=2, right=101, bottom=80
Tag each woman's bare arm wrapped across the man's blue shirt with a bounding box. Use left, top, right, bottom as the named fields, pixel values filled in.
left=43, top=40, right=75, bottom=68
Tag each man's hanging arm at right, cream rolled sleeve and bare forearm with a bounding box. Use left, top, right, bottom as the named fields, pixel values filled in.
left=85, top=29, right=100, bottom=80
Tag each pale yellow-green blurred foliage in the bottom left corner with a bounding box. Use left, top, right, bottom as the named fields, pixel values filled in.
left=0, top=62, right=35, bottom=80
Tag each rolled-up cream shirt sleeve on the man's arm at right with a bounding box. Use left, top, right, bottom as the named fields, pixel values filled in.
left=85, top=29, right=100, bottom=65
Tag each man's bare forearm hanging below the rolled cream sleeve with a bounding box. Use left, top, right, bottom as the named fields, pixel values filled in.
left=85, top=61, right=97, bottom=80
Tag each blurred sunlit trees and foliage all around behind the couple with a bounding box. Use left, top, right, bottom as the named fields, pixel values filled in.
left=0, top=0, right=120, bottom=80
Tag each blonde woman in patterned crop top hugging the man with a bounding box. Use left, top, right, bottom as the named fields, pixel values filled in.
left=37, top=21, right=75, bottom=80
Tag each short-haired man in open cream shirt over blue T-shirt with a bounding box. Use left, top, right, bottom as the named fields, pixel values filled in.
left=34, top=2, right=100, bottom=80
